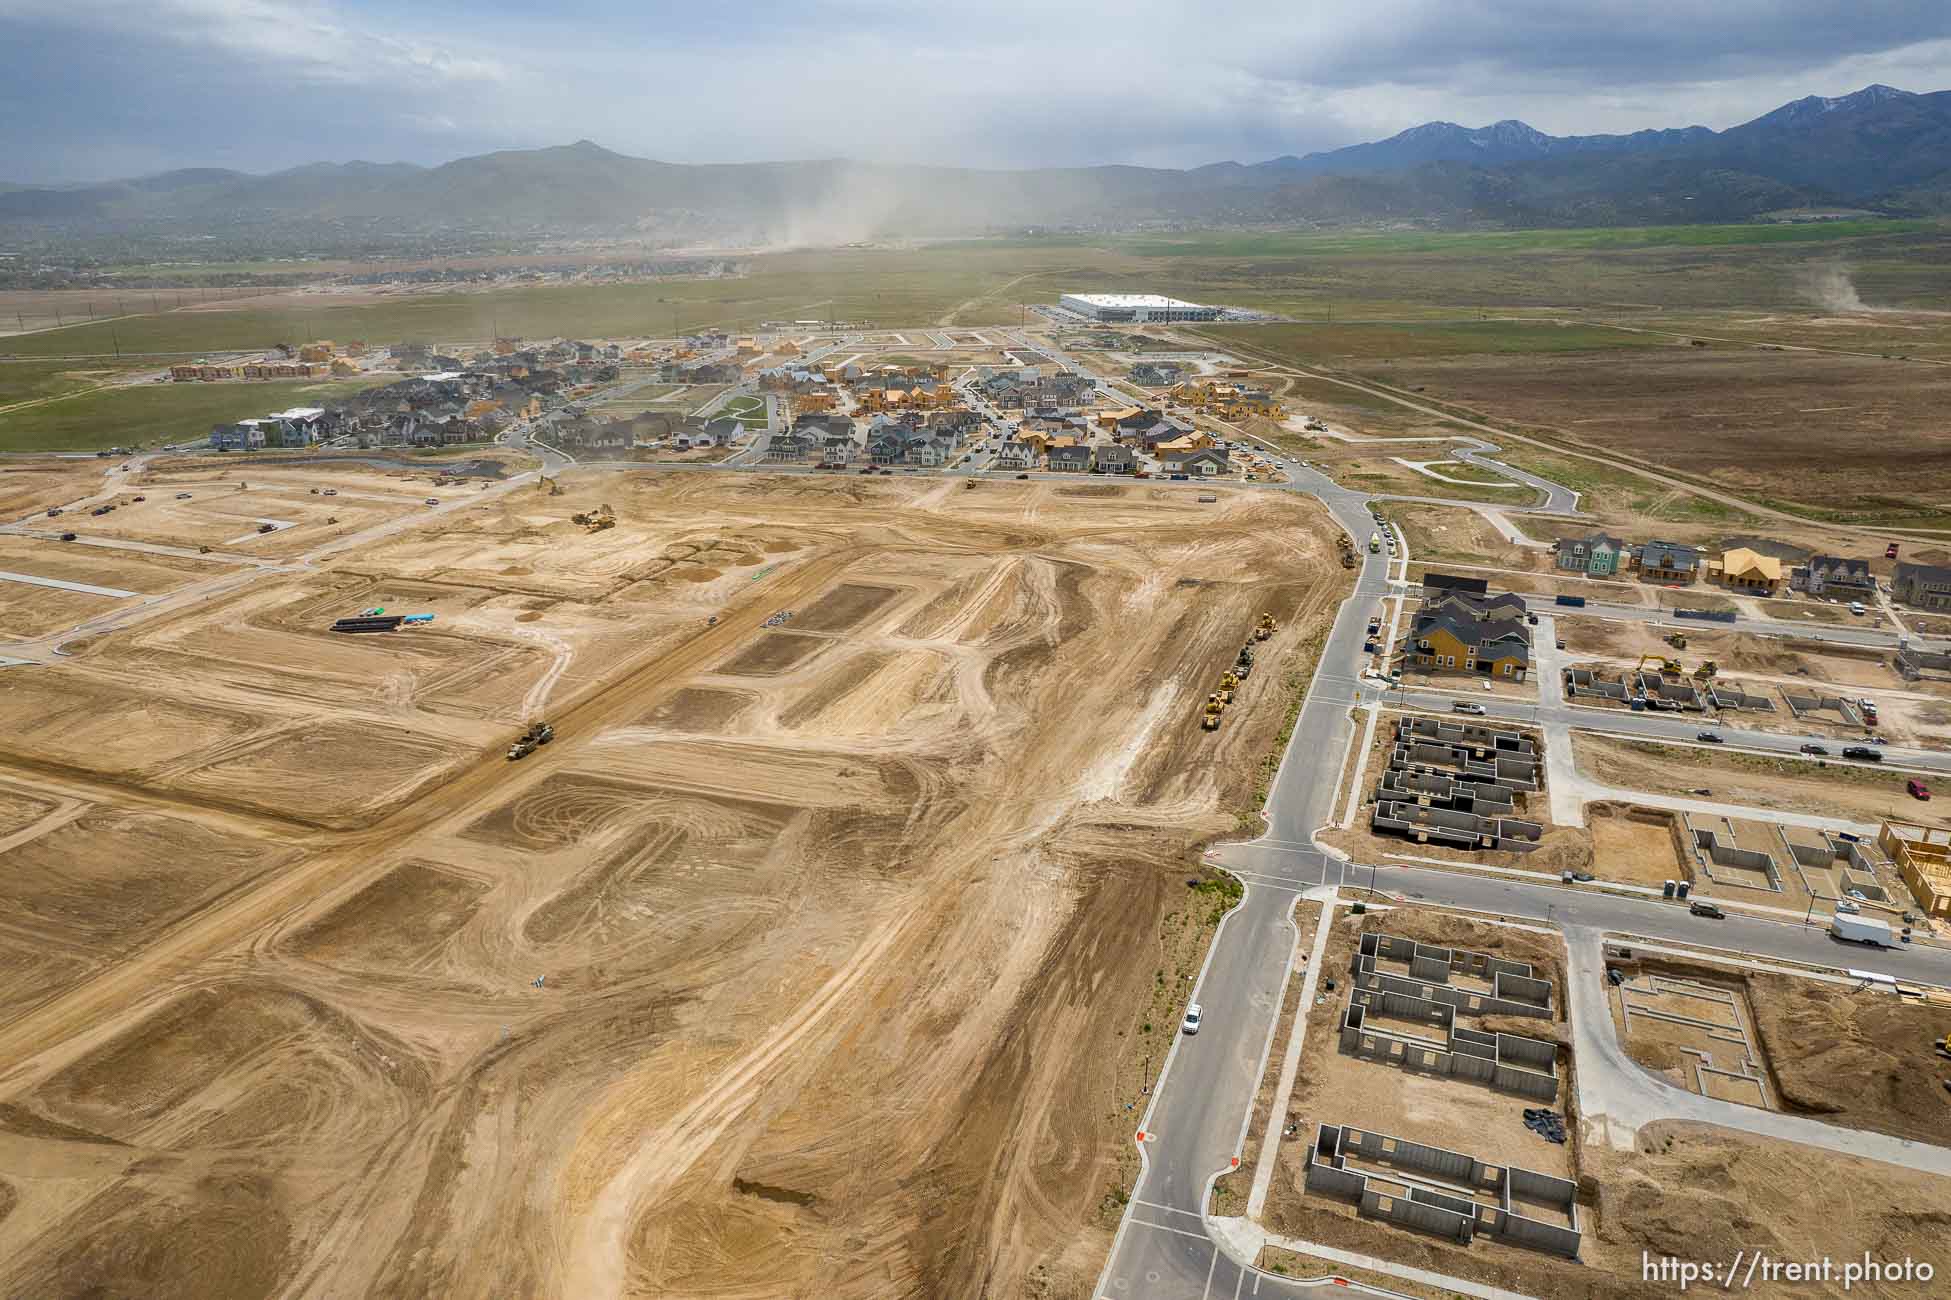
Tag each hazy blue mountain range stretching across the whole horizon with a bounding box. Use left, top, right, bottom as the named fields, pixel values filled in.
left=0, top=86, right=1951, bottom=244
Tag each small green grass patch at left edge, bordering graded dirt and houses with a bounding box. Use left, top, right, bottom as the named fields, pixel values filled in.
left=0, top=381, right=384, bottom=451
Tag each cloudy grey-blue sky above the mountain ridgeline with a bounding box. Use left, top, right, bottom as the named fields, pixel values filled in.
left=0, top=0, right=1951, bottom=182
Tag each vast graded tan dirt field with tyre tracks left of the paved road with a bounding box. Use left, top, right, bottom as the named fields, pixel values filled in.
left=0, top=458, right=1342, bottom=1298
